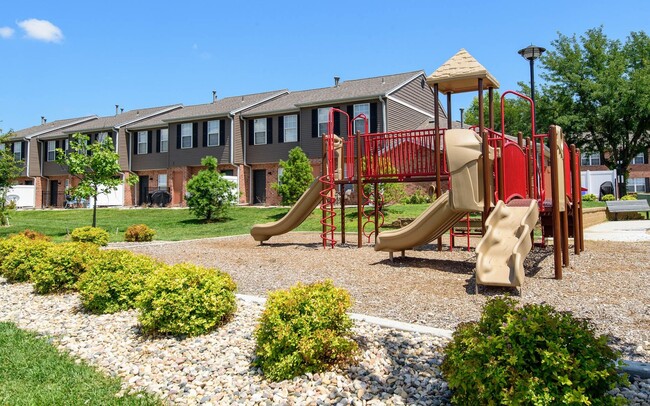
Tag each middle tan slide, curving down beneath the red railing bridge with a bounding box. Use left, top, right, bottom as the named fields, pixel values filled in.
left=375, top=192, right=467, bottom=252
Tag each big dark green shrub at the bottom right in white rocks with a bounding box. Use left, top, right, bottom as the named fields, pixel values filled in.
left=441, top=298, right=627, bottom=405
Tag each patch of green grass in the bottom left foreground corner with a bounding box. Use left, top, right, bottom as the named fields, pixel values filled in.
left=0, top=323, right=161, bottom=405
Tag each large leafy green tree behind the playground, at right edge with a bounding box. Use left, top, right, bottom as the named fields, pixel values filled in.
left=541, top=27, right=650, bottom=196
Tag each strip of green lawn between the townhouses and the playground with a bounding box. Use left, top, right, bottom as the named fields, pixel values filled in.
left=0, top=204, right=436, bottom=242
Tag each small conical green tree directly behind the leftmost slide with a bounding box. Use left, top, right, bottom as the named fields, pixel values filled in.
left=271, top=147, right=314, bottom=206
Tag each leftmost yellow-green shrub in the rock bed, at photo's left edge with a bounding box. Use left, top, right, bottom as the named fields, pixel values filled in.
left=0, top=236, right=54, bottom=282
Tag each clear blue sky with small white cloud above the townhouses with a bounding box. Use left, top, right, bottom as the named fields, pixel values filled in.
left=0, top=0, right=650, bottom=131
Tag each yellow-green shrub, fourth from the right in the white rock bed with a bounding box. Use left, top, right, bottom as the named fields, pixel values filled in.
left=77, top=250, right=159, bottom=314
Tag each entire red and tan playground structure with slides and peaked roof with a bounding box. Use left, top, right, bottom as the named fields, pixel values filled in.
left=251, top=50, right=584, bottom=286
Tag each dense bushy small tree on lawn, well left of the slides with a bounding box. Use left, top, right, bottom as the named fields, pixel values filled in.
left=187, top=156, right=237, bottom=221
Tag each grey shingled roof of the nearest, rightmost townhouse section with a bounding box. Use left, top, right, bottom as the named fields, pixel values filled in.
left=243, top=71, right=424, bottom=117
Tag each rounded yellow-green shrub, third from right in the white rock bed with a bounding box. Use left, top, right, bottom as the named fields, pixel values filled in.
left=137, top=264, right=236, bottom=336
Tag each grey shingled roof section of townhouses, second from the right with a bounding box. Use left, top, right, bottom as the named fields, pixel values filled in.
left=147, top=90, right=288, bottom=129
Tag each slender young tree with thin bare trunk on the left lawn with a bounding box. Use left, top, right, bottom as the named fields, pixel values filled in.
left=56, top=133, right=138, bottom=227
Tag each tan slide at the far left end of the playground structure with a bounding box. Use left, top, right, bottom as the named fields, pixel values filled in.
left=251, top=179, right=321, bottom=242
